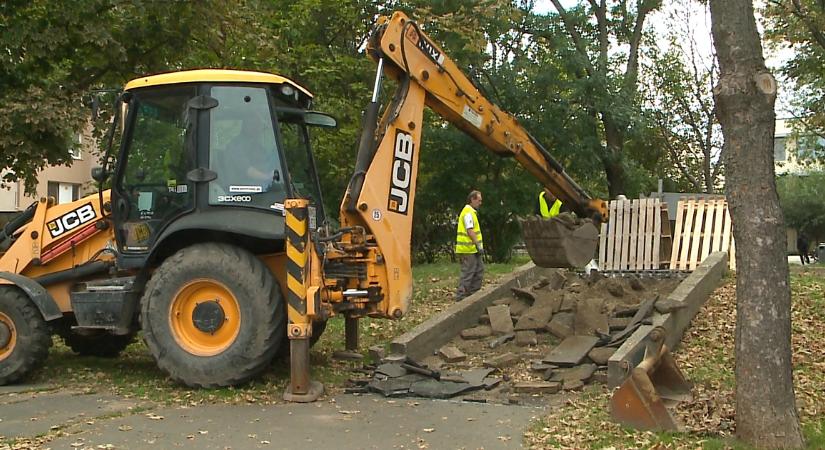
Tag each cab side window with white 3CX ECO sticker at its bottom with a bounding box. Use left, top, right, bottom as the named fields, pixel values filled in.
left=209, top=86, right=286, bottom=211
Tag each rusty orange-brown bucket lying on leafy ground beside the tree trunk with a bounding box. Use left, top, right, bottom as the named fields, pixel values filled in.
left=610, top=333, right=692, bottom=431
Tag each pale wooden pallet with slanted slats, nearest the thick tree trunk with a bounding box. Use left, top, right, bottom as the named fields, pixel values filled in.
left=670, top=198, right=736, bottom=271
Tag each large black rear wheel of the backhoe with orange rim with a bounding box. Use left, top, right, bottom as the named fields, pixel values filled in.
left=140, top=243, right=286, bottom=388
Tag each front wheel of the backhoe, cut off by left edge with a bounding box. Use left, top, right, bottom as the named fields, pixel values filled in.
left=0, top=286, right=52, bottom=385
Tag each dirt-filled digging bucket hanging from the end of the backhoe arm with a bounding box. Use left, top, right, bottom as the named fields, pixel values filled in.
left=521, top=213, right=599, bottom=268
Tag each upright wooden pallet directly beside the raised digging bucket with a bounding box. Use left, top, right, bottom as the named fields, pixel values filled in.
left=599, top=198, right=671, bottom=272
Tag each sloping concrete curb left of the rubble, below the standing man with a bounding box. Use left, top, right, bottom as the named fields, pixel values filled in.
left=390, top=262, right=557, bottom=359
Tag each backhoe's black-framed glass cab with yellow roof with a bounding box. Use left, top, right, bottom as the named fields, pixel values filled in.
left=112, top=70, right=336, bottom=267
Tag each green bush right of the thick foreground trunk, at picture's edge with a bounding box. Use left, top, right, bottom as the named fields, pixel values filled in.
left=777, top=172, right=825, bottom=239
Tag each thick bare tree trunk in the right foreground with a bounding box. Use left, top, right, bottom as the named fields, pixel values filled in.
left=710, top=0, right=804, bottom=448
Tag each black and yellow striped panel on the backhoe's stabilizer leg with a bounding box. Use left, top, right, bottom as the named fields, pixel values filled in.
left=286, top=204, right=309, bottom=323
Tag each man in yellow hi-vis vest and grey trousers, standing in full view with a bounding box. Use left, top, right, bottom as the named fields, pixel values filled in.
left=455, top=191, right=484, bottom=301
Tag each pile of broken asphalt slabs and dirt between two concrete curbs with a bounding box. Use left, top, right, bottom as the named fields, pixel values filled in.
left=349, top=270, right=678, bottom=403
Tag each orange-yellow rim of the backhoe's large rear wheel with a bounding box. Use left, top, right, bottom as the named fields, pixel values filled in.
left=169, top=278, right=241, bottom=356
